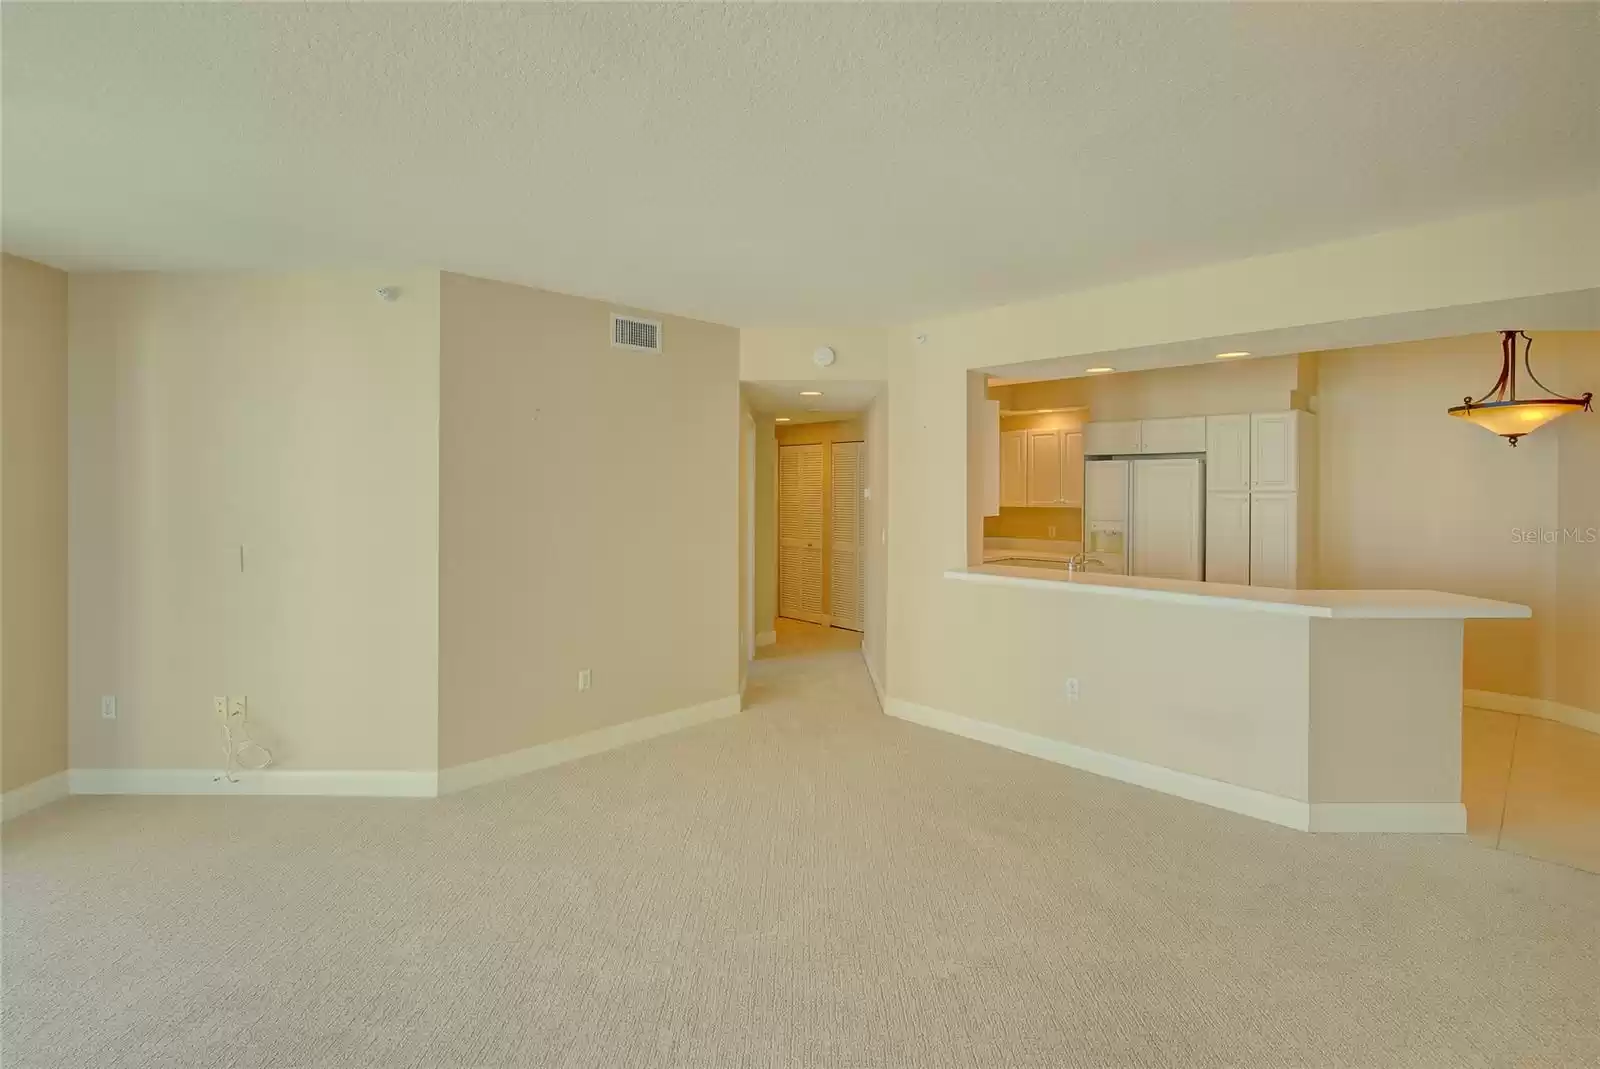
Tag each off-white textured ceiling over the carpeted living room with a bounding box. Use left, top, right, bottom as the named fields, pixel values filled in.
left=0, top=3, right=1600, bottom=325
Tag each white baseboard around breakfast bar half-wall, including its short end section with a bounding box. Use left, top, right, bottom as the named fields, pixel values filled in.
left=883, top=698, right=1467, bottom=832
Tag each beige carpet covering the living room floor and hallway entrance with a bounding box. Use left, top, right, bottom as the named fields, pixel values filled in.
left=3, top=630, right=1600, bottom=1069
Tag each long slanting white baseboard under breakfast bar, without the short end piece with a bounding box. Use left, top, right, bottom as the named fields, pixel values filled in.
left=885, top=698, right=1310, bottom=831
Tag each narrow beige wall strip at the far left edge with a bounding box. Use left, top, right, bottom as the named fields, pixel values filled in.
left=0, top=256, right=67, bottom=791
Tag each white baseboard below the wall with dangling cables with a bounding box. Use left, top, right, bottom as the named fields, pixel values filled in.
left=67, top=768, right=438, bottom=799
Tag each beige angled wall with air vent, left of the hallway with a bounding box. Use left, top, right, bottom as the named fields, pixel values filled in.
left=438, top=274, right=739, bottom=767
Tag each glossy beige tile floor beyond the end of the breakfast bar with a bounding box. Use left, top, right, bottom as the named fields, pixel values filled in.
left=1461, top=709, right=1600, bottom=872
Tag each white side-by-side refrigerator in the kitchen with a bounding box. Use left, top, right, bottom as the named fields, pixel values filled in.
left=1083, top=456, right=1205, bottom=579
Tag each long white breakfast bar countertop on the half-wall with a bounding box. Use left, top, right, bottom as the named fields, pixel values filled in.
left=944, top=565, right=1533, bottom=619
